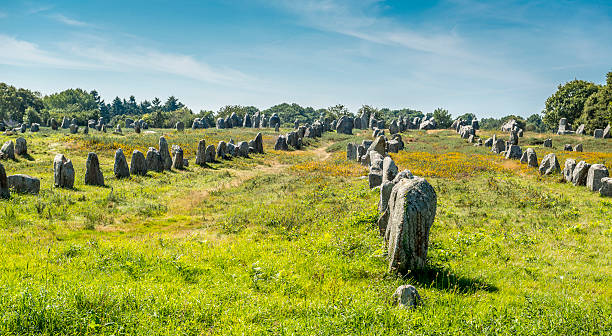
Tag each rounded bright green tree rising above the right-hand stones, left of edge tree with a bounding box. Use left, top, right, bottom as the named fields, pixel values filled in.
left=542, top=80, right=599, bottom=129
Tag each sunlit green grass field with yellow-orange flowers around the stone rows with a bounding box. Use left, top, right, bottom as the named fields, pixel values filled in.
left=0, top=129, right=612, bottom=335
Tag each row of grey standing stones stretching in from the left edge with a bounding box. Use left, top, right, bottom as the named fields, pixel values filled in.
left=0, top=133, right=264, bottom=198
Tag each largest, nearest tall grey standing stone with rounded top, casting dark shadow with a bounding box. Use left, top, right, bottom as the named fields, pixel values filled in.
left=385, top=177, right=437, bottom=274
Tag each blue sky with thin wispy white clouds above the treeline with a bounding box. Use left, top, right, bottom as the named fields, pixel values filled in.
left=0, top=0, right=612, bottom=118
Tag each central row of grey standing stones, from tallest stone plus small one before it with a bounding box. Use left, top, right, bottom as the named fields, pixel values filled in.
left=347, top=134, right=437, bottom=308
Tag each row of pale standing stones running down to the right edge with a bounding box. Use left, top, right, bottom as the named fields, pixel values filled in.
left=452, top=118, right=612, bottom=197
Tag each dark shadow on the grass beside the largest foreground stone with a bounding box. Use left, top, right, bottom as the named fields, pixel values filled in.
left=406, top=266, right=498, bottom=294
